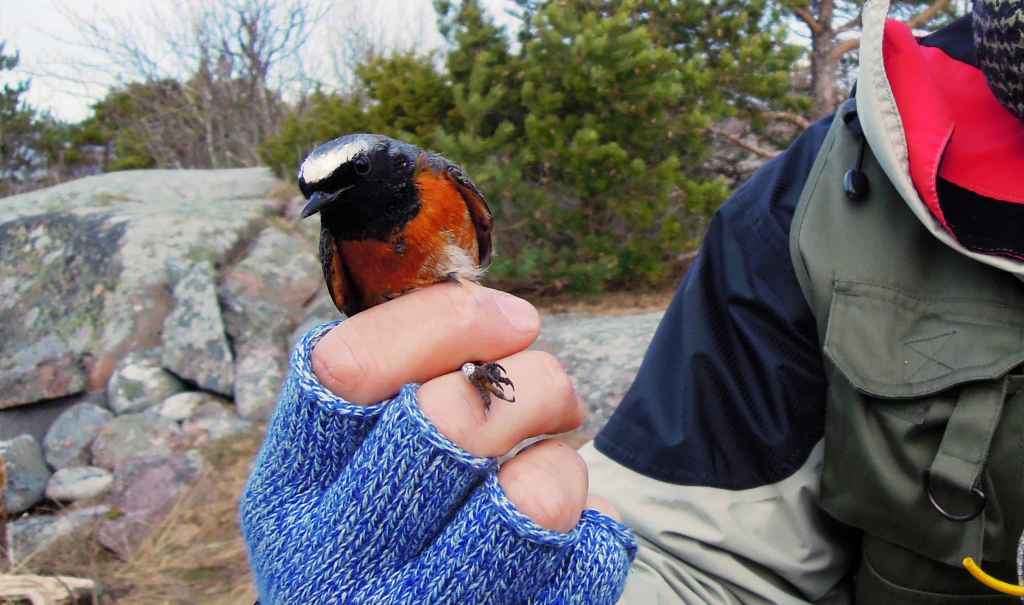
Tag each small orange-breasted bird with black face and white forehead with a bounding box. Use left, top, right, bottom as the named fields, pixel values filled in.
left=299, top=133, right=515, bottom=407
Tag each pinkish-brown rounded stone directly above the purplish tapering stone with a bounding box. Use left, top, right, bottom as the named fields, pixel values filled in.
left=92, top=413, right=181, bottom=469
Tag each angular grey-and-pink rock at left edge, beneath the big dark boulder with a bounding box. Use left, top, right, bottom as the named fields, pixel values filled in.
left=0, top=334, right=87, bottom=409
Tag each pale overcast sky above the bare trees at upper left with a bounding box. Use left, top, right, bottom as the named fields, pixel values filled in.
left=0, top=0, right=513, bottom=121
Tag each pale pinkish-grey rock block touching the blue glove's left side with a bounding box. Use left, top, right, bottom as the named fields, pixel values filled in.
left=234, top=344, right=288, bottom=420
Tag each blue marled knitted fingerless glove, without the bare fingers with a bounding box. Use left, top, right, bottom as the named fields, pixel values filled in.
left=242, top=322, right=636, bottom=605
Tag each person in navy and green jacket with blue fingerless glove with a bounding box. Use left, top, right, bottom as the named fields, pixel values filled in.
left=242, top=0, right=1024, bottom=605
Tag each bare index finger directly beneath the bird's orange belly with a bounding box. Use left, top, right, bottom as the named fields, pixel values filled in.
left=312, top=282, right=541, bottom=404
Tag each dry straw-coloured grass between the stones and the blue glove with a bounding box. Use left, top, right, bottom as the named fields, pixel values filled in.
left=15, top=431, right=262, bottom=605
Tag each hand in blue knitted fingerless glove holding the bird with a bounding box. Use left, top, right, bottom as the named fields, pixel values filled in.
left=242, top=284, right=635, bottom=605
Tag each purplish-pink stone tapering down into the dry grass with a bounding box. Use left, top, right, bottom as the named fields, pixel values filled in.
left=97, top=455, right=202, bottom=560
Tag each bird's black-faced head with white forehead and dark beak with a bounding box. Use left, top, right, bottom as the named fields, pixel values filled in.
left=299, top=133, right=422, bottom=239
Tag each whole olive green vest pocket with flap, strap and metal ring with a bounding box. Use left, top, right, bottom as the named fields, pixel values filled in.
left=821, top=282, right=1024, bottom=567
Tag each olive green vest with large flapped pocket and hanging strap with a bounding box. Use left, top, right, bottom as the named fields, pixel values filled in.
left=791, top=101, right=1024, bottom=605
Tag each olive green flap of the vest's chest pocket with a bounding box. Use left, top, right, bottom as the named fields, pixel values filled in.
left=824, top=282, right=1024, bottom=398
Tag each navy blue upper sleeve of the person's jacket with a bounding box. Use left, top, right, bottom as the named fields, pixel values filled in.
left=595, top=118, right=830, bottom=489
